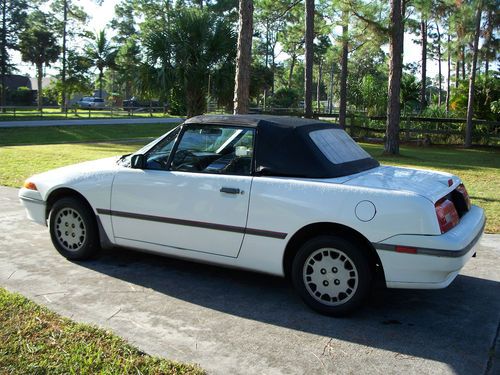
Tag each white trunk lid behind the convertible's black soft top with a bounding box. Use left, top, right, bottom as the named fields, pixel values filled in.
left=344, top=165, right=460, bottom=203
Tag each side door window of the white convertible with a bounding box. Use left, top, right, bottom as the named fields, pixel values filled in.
left=171, top=125, right=254, bottom=176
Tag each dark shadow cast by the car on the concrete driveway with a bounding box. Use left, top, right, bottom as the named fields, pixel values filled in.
left=79, top=248, right=500, bottom=374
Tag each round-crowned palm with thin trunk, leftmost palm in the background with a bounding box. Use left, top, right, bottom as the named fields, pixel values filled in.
left=19, top=10, right=60, bottom=110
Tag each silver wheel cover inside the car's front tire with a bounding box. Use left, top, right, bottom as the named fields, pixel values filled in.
left=55, top=208, right=87, bottom=251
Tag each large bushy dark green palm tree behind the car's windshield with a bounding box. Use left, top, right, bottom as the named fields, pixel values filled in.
left=145, top=7, right=236, bottom=117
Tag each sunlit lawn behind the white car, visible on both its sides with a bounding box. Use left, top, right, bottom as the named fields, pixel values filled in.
left=0, top=124, right=500, bottom=233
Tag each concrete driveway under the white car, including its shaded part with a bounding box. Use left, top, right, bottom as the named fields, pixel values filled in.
left=0, top=187, right=500, bottom=375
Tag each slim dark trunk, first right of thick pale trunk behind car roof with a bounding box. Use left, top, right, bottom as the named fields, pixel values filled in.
left=304, top=0, right=314, bottom=118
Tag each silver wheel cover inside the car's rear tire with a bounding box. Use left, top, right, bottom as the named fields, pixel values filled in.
left=302, top=248, right=359, bottom=306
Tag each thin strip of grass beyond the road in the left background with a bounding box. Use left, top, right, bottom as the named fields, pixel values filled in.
left=0, top=108, right=177, bottom=122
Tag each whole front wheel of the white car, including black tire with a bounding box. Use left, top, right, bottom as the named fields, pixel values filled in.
left=49, top=197, right=100, bottom=260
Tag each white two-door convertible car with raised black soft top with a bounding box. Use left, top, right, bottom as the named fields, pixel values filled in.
left=19, top=115, right=485, bottom=315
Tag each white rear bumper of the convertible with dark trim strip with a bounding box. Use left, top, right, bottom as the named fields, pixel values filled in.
left=373, top=206, right=486, bottom=289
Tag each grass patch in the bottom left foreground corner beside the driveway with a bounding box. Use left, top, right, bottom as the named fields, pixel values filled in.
left=0, top=288, right=204, bottom=375
